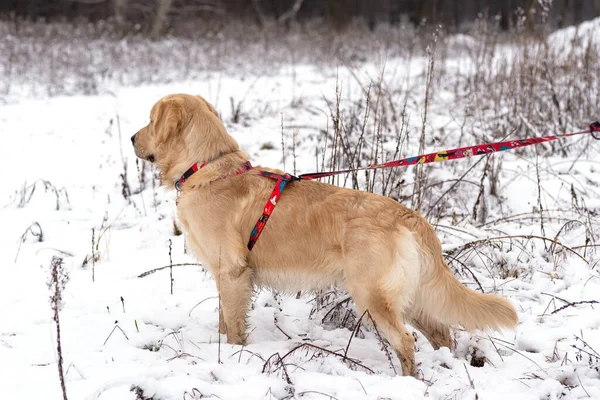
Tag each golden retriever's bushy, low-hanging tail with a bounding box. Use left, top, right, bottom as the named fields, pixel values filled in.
left=417, top=229, right=518, bottom=331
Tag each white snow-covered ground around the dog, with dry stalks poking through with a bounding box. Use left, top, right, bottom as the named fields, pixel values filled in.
left=0, top=21, right=600, bottom=400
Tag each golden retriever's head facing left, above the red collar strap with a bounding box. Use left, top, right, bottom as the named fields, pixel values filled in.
left=131, top=94, right=239, bottom=186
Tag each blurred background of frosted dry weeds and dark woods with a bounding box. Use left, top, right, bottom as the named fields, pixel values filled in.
left=0, top=0, right=600, bottom=97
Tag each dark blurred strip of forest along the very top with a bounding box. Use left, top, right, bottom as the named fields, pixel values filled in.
left=0, top=0, right=600, bottom=38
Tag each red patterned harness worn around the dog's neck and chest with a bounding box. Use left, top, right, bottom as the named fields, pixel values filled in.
left=175, top=161, right=300, bottom=250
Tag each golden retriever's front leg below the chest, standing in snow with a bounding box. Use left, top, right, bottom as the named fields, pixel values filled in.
left=217, top=267, right=252, bottom=344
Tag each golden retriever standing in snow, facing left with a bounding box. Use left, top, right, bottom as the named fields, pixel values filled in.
left=131, top=94, right=518, bottom=376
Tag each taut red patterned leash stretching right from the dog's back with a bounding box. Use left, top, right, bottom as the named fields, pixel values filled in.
left=298, top=121, right=600, bottom=180
